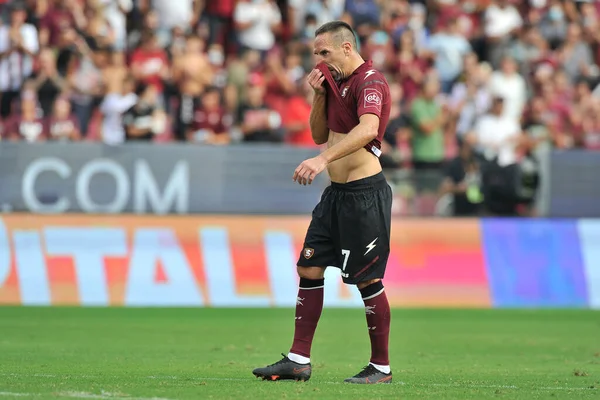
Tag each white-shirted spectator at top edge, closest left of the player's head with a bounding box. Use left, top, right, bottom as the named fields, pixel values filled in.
left=233, top=0, right=281, bottom=54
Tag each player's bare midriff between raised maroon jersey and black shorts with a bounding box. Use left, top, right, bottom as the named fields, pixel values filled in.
left=327, top=130, right=381, bottom=183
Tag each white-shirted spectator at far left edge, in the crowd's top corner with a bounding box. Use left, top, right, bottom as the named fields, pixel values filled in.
left=0, top=3, right=39, bottom=118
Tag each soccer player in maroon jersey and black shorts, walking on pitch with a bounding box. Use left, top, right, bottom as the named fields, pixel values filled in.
left=253, top=21, right=392, bottom=384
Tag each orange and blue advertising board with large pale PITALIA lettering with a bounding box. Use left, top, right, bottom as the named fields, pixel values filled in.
left=0, top=214, right=600, bottom=308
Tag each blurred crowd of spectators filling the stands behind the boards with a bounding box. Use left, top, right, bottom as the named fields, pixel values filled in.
left=0, top=0, right=600, bottom=163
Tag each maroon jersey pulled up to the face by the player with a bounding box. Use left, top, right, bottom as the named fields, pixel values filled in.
left=327, top=61, right=391, bottom=157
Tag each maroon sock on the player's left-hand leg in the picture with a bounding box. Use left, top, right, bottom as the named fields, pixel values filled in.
left=288, top=278, right=325, bottom=364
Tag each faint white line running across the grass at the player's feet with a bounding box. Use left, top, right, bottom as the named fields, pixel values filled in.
left=0, top=373, right=599, bottom=392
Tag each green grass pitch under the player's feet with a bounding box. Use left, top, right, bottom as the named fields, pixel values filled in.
left=0, top=307, right=600, bottom=400
